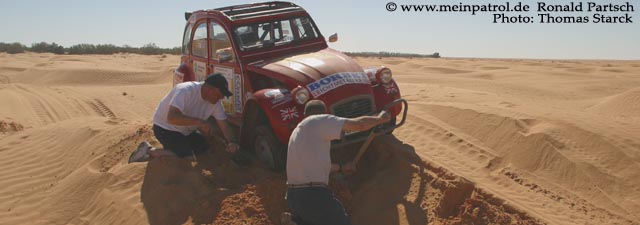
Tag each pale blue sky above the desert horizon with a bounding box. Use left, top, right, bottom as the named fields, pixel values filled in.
left=0, top=0, right=640, bottom=59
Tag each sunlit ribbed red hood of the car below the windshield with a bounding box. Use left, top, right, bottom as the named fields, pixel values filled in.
left=251, top=48, right=363, bottom=85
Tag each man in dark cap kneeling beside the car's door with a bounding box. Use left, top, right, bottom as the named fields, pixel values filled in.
left=129, top=74, right=239, bottom=163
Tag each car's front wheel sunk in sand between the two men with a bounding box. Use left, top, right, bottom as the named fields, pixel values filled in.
left=253, top=125, right=287, bottom=172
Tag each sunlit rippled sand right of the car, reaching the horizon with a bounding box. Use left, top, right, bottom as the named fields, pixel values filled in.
left=360, top=59, right=640, bottom=224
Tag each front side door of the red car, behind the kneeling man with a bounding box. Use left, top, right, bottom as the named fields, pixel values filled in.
left=209, top=20, right=244, bottom=125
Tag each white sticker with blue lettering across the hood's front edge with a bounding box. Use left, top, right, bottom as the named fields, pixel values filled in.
left=307, top=72, right=370, bottom=98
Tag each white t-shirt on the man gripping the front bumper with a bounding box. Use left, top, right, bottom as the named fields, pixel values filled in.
left=287, top=114, right=347, bottom=184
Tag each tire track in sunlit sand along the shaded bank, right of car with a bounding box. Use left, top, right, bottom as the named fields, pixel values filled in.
left=396, top=110, right=630, bottom=224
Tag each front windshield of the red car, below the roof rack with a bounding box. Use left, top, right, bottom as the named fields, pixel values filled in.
left=234, top=17, right=319, bottom=51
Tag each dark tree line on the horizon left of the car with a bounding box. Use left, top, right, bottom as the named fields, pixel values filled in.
left=0, top=42, right=180, bottom=55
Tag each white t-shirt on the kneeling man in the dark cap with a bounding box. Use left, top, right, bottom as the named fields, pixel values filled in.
left=153, top=81, right=227, bottom=135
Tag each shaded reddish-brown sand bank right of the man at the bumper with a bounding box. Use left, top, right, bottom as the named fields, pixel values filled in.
left=346, top=136, right=542, bottom=224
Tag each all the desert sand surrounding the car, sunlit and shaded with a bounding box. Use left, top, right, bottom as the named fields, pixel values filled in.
left=0, top=53, right=640, bottom=225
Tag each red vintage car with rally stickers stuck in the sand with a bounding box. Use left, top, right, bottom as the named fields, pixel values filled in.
left=174, top=2, right=406, bottom=170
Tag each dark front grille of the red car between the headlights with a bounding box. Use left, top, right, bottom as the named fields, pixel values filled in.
left=331, top=95, right=373, bottom=118
